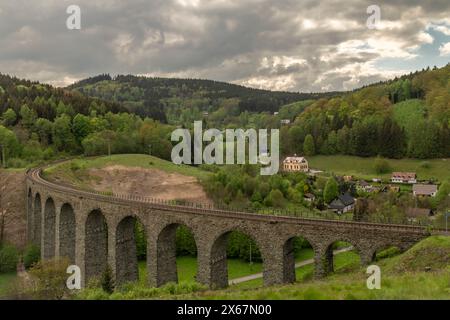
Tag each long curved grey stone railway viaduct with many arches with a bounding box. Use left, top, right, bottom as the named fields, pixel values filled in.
left=26, top=169, right=428, bottom=289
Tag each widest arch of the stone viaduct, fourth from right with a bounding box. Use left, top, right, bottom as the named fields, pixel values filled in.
left=210, top=227, right=267, bottom=289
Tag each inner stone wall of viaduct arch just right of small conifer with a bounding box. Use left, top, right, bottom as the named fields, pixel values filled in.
left=115, top=216, right=142, bottom=284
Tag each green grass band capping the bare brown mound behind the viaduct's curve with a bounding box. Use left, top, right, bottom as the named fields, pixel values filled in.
left=44, top=154, right=211, bottom=188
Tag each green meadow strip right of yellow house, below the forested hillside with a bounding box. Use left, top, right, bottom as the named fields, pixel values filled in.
left=308, top=155, right=450, bottom=181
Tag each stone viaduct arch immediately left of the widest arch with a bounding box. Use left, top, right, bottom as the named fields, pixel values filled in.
left=153, top=221, right=198, bottom=286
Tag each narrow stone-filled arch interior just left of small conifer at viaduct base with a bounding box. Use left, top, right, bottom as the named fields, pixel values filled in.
left=85, top=209, right=108, bottom=283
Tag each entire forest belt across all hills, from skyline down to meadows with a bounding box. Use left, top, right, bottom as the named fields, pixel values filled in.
left=0, top=64, right=450, bottom=167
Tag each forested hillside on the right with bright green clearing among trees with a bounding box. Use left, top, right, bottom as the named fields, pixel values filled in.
left=281, top=64, right=450, bottom=158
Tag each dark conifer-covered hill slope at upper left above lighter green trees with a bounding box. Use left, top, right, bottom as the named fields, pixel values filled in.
left=0, top=73, right=126, bottom=124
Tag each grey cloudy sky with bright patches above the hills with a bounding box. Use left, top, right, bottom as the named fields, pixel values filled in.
left=0, top=0, right=450, bottom=92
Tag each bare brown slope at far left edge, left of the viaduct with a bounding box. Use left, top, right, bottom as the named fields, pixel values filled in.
left=0, top=170, right=27, bottom=248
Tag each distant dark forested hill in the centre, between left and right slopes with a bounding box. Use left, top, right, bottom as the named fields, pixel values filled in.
left=68, top=74, right=337, bottom=124
